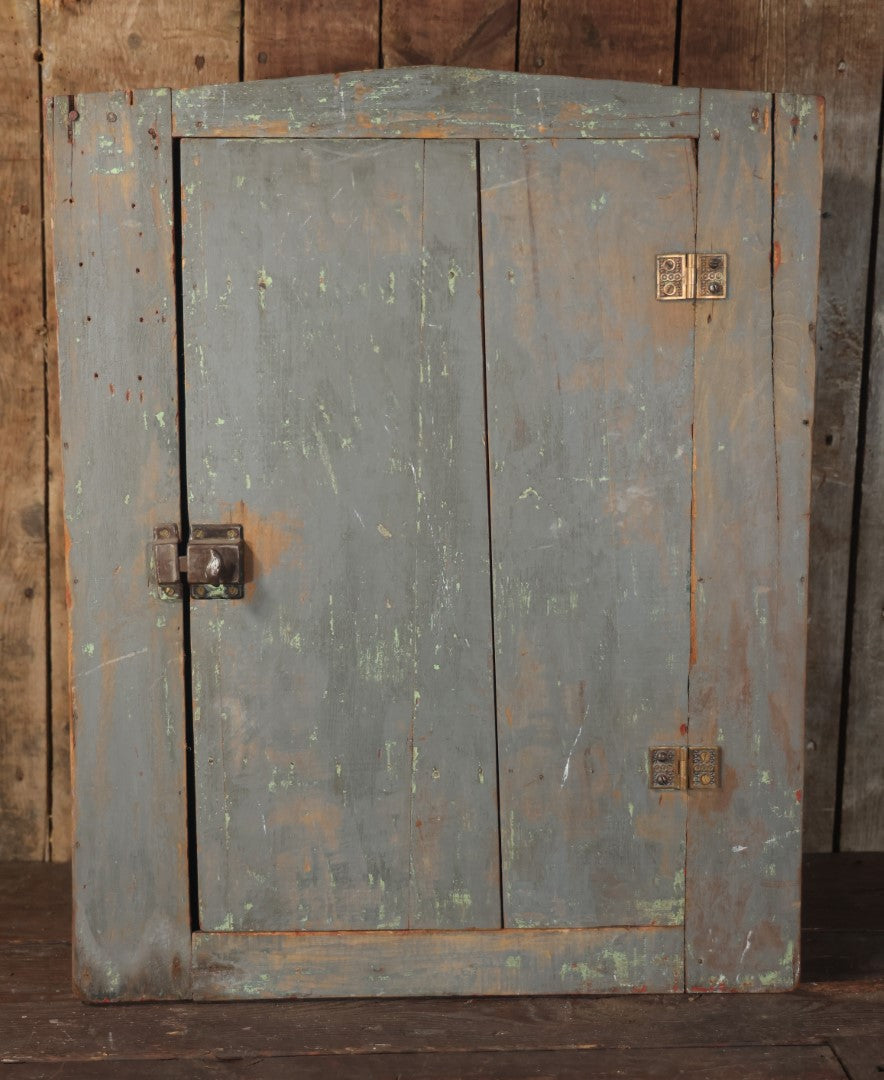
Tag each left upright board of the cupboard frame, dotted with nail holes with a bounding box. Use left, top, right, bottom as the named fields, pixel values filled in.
left=47, top=91, right=190, bottom=1000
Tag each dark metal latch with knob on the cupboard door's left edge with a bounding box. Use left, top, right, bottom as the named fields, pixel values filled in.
left=151, top=523, right=245, bottom=600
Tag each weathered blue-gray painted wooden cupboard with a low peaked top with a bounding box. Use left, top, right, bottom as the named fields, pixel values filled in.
left=47, top=68, right=821, bottom=1001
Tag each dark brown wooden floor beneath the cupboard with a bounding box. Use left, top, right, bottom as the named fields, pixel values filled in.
left=0, top=855, right=884, bottom=1080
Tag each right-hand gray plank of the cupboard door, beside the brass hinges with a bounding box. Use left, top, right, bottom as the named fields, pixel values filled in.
left=481, top=140, right=695, bottom=927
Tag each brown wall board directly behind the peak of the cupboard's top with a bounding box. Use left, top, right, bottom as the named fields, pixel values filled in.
left=381, top=0, right=519, bottom=71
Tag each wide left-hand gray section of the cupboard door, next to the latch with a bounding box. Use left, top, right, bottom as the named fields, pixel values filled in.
left=181, top=139, right=501, bottom=930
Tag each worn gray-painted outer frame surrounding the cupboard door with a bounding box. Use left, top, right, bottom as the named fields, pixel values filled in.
left=46, top=68, right=822, bottom=1001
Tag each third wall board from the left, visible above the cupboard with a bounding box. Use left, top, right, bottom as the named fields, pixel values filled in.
left=243, top=0, right=380, bottom=79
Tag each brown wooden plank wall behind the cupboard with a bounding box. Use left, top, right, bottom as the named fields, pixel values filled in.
left=0, top=0, right=884, bottom=860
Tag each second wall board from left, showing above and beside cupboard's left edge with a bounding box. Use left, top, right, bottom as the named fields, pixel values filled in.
left=40, top=0, right=240, bottom=860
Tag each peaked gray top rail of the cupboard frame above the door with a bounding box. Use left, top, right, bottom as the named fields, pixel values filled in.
left=173, top=67, right=698, bottom=138
